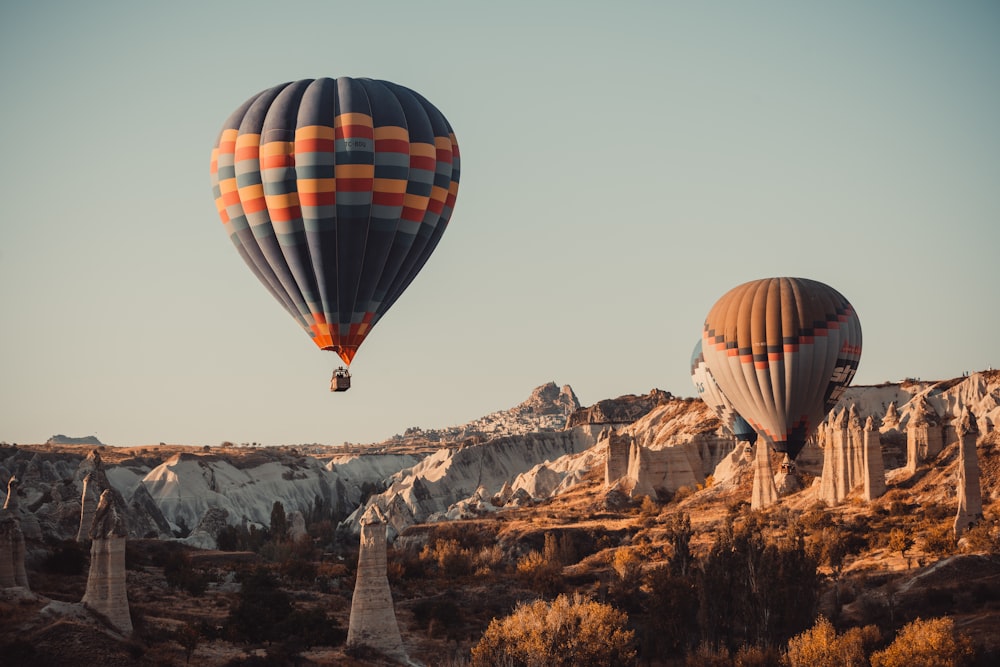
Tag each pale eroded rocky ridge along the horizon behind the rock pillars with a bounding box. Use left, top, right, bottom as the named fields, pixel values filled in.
left=0, top=371, right=1000, bottom=552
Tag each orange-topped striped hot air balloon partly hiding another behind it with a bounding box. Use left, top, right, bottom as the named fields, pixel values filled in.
left=702, top=278, right=861, bottom=460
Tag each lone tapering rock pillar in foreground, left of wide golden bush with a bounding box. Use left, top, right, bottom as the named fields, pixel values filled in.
left=347, top=505, right=408, bottom=662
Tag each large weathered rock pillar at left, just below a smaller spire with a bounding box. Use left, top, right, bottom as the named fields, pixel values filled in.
left=82, top=489, right=132, bottom=635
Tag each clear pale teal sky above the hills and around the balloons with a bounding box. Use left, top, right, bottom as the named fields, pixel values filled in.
left=0, top=0, right=1000, bottom=445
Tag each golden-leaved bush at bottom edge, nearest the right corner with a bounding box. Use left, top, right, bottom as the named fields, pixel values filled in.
left=871, top=617, right=975, bottom=667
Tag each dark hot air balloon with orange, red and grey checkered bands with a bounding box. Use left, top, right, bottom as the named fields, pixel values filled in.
left=211, top=77, right=460, bottom=391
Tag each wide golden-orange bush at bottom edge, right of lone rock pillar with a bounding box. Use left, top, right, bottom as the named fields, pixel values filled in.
left=472, top=593, right=635, bottom=667
